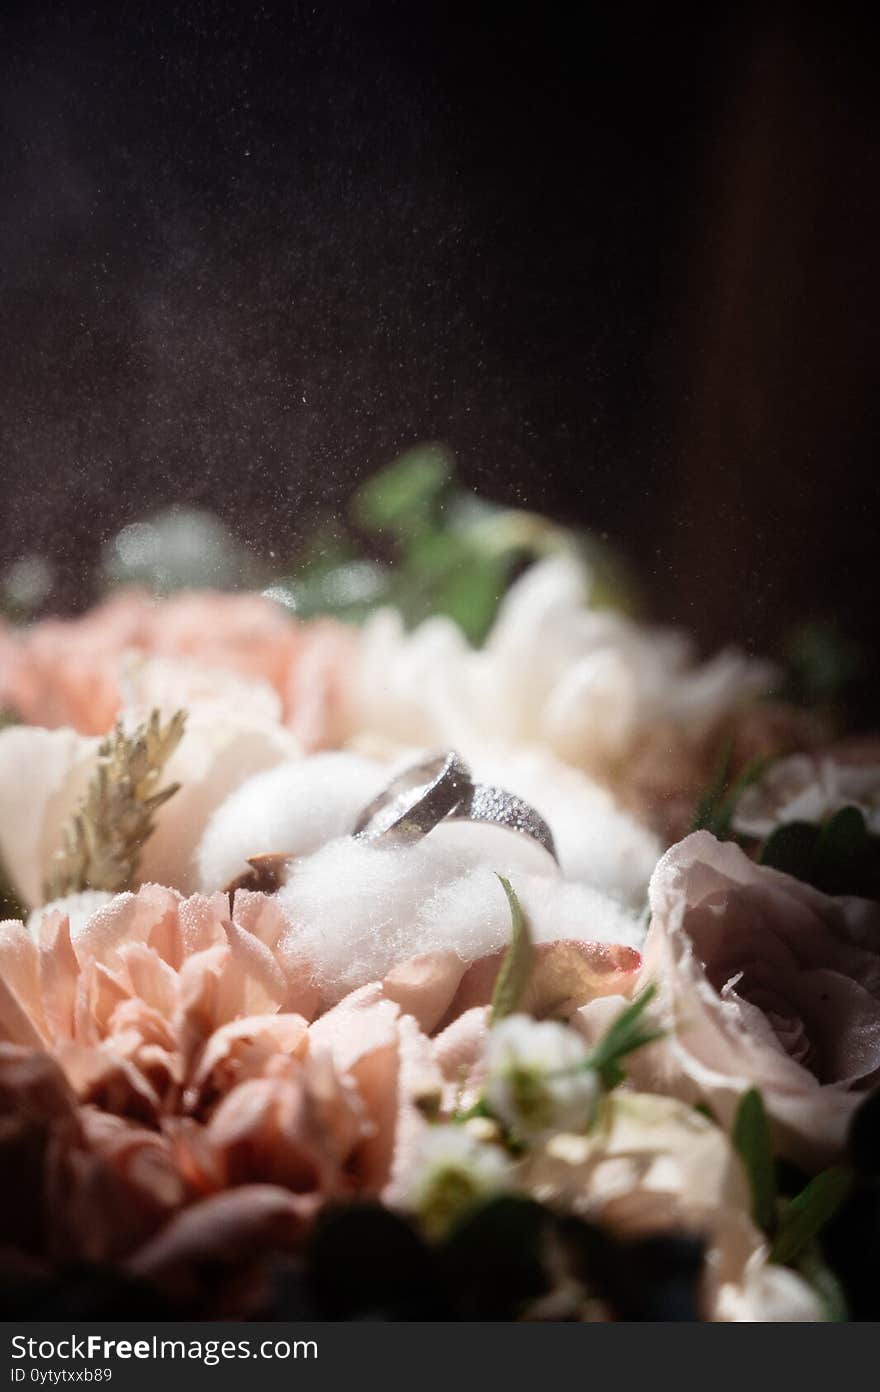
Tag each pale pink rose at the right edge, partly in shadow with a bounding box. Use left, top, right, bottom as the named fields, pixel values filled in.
left=629, top=831, right=880, bottom=1168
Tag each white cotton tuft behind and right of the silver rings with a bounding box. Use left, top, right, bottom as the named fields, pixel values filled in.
left=472, top=749, right=661, bottom=909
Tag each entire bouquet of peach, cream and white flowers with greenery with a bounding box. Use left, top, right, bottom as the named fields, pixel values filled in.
left=0, top=451, right=880, bottom=1321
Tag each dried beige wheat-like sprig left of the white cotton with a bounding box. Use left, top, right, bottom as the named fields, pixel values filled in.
left=45, top=710, right=187, bottom=901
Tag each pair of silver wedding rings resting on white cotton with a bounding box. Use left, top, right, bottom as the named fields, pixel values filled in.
left=352, top=750, right=558, bottom=863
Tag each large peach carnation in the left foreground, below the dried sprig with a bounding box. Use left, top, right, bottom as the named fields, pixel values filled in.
left=0, top=885, right=453, bottom=1258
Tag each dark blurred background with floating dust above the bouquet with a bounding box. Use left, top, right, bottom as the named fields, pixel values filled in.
left=0, top=0, right=880, bottom=649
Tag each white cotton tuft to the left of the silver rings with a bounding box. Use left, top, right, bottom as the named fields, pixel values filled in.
left=198, top=753, right=390, bottom=891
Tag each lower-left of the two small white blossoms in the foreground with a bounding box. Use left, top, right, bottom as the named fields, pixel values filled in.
left=405, top=1123, right=512, bottom=1236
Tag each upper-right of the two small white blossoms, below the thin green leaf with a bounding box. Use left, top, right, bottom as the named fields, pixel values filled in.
left=485, top=1015, right=599, bottom=1140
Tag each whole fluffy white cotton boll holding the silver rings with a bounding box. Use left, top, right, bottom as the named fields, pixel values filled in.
left=198, top=752, right=657, bottom=998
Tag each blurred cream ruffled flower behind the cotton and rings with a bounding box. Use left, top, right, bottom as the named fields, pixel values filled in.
left=336, top=557, right=770, bottom=778
